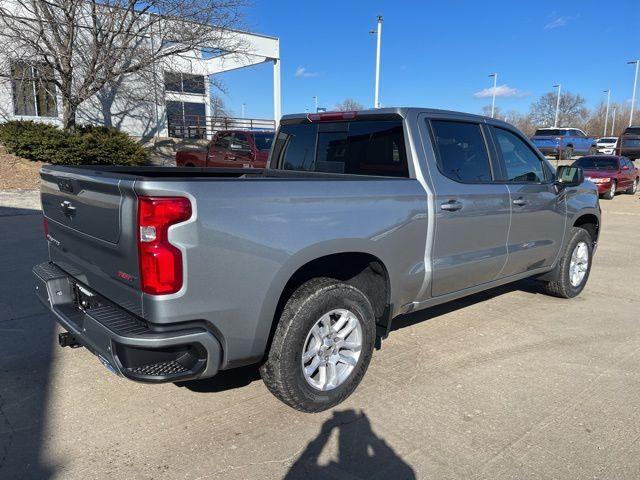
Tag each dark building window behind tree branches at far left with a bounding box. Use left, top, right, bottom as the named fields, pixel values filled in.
left=11, top=62, right=58, bottom=117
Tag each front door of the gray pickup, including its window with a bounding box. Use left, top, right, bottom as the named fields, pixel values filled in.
left=491, top=127, right=566, bottom=276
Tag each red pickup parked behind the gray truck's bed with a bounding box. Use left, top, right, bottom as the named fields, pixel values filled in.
left=176, top=130, right=274, bottom=168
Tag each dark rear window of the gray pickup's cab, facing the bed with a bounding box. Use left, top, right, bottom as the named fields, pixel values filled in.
left=271, top=120, right=409, bottom=177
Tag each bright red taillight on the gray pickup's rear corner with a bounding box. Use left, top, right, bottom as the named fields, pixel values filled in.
left=138, top=197, right=191, bottom=295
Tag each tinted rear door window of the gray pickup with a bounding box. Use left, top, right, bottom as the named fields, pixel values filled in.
left=431, top=120, right=492, bottom=182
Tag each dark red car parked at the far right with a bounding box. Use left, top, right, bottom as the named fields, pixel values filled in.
left=573, top=155, right=640, bottom=200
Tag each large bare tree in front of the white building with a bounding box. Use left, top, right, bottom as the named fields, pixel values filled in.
left=0, top=0, right=248, bottom=129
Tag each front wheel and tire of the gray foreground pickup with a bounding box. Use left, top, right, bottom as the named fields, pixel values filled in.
left=544, top=227, right=593, bottom=298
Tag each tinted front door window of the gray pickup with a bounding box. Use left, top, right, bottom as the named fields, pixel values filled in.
left=492, top=128, right=544, bottom=183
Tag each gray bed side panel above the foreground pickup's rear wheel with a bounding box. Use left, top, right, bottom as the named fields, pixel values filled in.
left=136, top=177, right=427, bottom=368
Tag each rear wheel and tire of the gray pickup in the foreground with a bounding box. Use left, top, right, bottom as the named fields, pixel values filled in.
left=260, top=278, right=376, bottom=412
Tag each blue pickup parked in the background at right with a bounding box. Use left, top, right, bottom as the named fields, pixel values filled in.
left=531, top=128, right=597, bottom=160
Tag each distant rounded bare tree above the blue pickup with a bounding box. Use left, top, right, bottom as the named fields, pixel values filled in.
left=529, top=92, right=589, bottom=127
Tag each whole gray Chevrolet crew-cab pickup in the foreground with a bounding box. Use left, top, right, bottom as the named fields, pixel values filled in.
left=33, top=108, right=600, bottom=412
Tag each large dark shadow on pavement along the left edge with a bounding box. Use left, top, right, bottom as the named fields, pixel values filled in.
left=0, top=207, right=56, bottom=479
